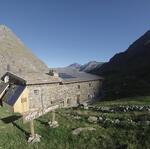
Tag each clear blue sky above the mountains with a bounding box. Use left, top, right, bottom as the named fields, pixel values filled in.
left=0, top=0, right=150, bottom=67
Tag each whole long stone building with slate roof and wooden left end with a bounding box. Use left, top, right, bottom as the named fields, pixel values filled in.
left=0, top=68, right=103, bottom=115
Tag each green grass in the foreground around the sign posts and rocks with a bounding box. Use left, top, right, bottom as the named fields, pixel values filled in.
left=0, top=97, right=150, bottom=149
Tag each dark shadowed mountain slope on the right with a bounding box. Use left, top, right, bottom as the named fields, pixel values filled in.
left=91, top=31, right=150, bottom=98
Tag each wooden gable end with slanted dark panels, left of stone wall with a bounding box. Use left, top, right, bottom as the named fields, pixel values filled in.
left=0, top=72, right=29, bottom=113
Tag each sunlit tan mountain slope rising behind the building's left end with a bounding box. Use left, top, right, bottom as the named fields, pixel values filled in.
left=0, top=25, right=48, bottom=76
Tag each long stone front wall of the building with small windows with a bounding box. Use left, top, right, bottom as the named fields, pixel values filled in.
left=27, top=80, right=102, bottom=109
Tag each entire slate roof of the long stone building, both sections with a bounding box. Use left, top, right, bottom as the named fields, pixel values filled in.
left=2, top=68, right=103, bottom=85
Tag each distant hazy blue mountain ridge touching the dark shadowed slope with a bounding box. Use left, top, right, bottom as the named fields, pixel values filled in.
left=79, top=61, right=104, bottom=72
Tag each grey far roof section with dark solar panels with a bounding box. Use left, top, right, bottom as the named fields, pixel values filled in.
left=55, top=68, right=103, bottom=83
